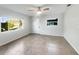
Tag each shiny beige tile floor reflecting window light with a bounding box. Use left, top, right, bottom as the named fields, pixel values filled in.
left=0, top=34, right=77, bottom=55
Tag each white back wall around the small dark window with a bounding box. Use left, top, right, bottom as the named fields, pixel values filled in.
left=32, top=13, right=64, bottom=36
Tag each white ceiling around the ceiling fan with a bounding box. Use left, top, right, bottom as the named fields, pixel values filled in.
left=0, top=4, right=67, bottom=16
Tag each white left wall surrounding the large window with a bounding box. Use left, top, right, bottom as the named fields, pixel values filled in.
left=0, top=7, right=31, bottom=46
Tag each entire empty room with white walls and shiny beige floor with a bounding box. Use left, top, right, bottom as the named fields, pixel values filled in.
left=0, top=4, right=79, bottom=55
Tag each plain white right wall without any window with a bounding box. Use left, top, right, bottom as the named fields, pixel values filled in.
left=64, top=5, right=79, bottom=54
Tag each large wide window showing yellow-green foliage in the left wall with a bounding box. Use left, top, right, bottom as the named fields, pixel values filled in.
left=0, top=17, right=22, bottom=32
